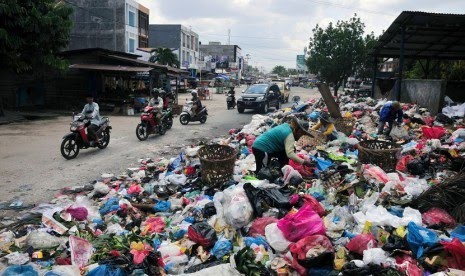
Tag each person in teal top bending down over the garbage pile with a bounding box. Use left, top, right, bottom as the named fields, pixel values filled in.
left=252, top=117, right=313, bottom=173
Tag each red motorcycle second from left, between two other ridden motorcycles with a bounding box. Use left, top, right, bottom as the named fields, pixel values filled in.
left=136, top=106, right=173, bottom=141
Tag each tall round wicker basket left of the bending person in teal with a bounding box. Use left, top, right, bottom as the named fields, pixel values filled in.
left=198, top=145, right=237, bottom=187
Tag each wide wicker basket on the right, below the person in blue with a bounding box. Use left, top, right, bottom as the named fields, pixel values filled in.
left=358, top=140, right=402, bottom=172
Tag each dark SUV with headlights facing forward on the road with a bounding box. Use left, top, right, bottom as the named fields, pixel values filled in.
left=237, top=83, right=282, bottom=113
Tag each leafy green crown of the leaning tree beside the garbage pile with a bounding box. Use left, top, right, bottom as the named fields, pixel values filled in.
left=307, top=15, right=366, bottom=95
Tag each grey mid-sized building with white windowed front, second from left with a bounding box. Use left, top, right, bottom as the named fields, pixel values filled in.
left=149, top=24, right=199, bottom=69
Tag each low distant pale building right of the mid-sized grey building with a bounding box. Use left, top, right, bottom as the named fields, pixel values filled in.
left=200, top=42, right=244, bottom=79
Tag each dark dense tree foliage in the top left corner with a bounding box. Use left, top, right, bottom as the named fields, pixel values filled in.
left=0, top=0, right=73, bottom=73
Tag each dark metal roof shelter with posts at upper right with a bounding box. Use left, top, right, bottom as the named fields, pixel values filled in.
left=370, top=11, right=465, bottom=98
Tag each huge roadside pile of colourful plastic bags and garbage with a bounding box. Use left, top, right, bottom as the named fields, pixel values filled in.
left=0, top=93, right=465, bottom=276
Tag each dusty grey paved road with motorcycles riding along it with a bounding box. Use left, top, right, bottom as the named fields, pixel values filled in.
left=0, top=87, right=318, bottom=210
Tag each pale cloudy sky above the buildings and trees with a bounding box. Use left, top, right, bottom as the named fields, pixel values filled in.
left=139, top=0, right=465, bottom=71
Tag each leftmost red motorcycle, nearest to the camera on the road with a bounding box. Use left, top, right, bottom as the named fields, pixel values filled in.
left=60, top=113, right=112, bottom=160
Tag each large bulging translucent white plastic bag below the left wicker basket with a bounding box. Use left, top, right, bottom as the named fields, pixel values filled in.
left=222, top=186, right=253, bottom=229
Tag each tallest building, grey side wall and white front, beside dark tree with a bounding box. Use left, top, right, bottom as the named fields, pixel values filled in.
left=66, top=0, right=150, bottom=55
